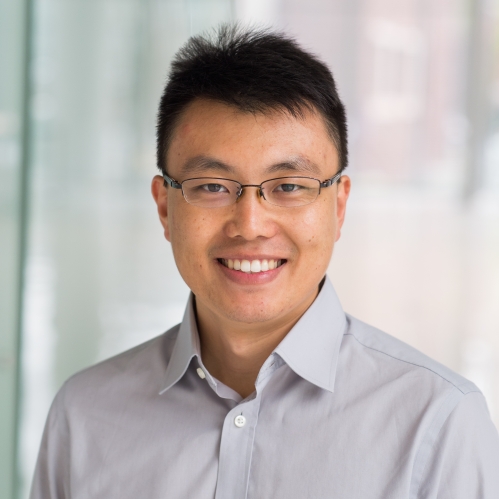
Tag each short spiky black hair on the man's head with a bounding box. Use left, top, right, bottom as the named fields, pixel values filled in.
left=157, top=24, right=348, bottom=172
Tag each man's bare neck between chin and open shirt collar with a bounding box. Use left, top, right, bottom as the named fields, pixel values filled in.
left=196, top=292, right=317, bottom=398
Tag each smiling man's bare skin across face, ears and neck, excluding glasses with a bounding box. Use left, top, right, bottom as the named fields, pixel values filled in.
left=152, top=99, right=350, bottom=398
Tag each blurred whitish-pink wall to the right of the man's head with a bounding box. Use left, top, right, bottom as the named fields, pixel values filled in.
left=236, top=0, right=499, bottom=426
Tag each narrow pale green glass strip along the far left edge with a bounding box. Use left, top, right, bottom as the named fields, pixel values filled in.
left=0, top=0, right=27, bottom=499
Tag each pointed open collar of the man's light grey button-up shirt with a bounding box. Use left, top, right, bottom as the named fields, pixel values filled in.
left=160, top=276, right=346, bottom=393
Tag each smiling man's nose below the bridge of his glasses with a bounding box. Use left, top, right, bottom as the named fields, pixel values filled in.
left=226, top=185, right=276, bottom=241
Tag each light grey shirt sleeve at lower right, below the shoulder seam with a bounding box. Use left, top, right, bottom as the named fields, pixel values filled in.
left=417, top=392, right=499, bottom=499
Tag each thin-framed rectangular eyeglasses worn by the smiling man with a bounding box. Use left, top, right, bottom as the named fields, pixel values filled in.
left=163, top=172, right=341, bottom=208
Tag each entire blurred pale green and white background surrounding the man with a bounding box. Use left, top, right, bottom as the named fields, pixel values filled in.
left=0, top=0, right=499, bottom=499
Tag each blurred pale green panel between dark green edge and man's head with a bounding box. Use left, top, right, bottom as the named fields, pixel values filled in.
left=20, top=0, right=232, bottom=498
